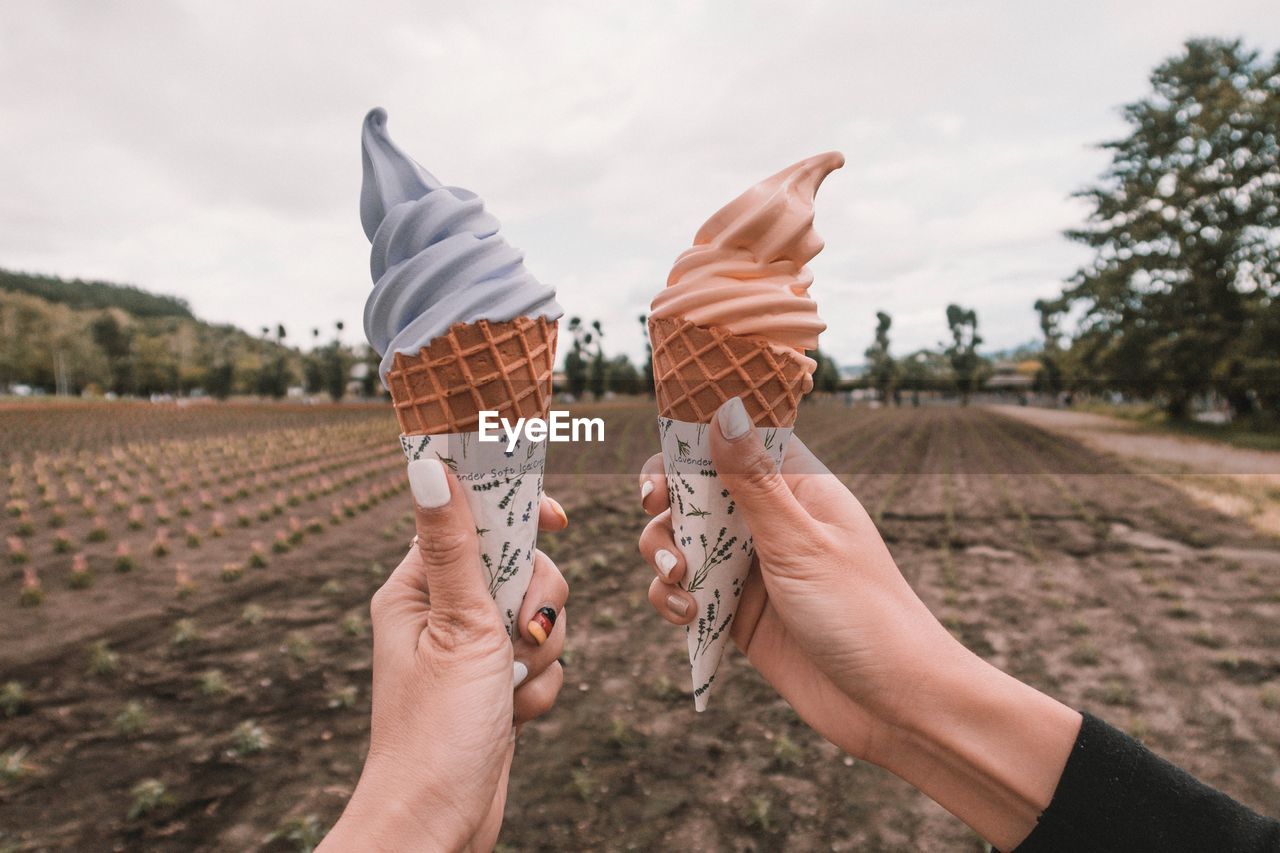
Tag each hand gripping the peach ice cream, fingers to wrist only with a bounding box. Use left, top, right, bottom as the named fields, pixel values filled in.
left=640, top=402, right=954, bottom=758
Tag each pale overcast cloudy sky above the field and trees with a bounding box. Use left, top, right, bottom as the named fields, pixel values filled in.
left=0, top=0, right=1280, bottom=364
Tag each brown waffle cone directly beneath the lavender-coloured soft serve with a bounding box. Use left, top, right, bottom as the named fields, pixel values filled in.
left=387, top=316, right=557, bottom=435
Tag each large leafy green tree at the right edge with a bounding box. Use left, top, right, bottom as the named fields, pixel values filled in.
left=1053, top=40, right=1280, bottom=418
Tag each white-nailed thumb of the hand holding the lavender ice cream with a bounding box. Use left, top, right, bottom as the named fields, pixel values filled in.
left=408, top=459, right=498, bottom=616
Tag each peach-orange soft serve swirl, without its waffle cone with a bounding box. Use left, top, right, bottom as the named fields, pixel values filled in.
left=650, top=151, right=845, bottom=392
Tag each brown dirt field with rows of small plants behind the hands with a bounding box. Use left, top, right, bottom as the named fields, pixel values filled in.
left=0, top=403, right=1280, bottom=850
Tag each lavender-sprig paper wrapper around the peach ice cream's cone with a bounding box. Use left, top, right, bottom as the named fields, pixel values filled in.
left=658, top=418, right=791, bottom=711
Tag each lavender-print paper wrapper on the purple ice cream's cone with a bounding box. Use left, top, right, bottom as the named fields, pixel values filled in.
left=401, top=432, right=547, bottom=640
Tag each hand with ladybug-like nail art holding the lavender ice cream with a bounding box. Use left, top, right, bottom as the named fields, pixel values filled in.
left=325, top=460, right=568, bottom=850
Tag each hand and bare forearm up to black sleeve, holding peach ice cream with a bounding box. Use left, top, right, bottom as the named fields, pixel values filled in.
left=640, top=400, right=1080, bottom=849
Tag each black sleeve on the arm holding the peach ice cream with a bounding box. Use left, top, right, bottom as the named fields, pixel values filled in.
left=1016, top=713, right=1280, bottom=853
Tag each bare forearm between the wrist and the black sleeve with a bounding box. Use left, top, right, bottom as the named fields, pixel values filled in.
left=868, top=642, right=1080, bottom=850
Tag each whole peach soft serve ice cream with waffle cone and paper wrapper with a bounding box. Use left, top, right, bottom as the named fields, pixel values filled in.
left=649, top=151, right=845, bottom=711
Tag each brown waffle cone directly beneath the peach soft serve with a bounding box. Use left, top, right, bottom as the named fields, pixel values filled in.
left=649, top=318, right=809, bottom=427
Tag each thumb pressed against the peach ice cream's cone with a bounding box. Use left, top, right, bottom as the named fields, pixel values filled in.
left=708, top=397, right=814, bottom=555
